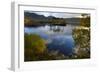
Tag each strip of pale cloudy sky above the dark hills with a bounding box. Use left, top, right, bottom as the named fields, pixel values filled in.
left=28, top=11, right=90, bottom=18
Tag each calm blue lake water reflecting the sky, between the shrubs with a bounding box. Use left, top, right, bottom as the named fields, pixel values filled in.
left=24, top=25, right=75, bottom=55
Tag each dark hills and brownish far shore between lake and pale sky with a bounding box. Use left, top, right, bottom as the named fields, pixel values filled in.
left=24, top=12, right=80, bottom=26
